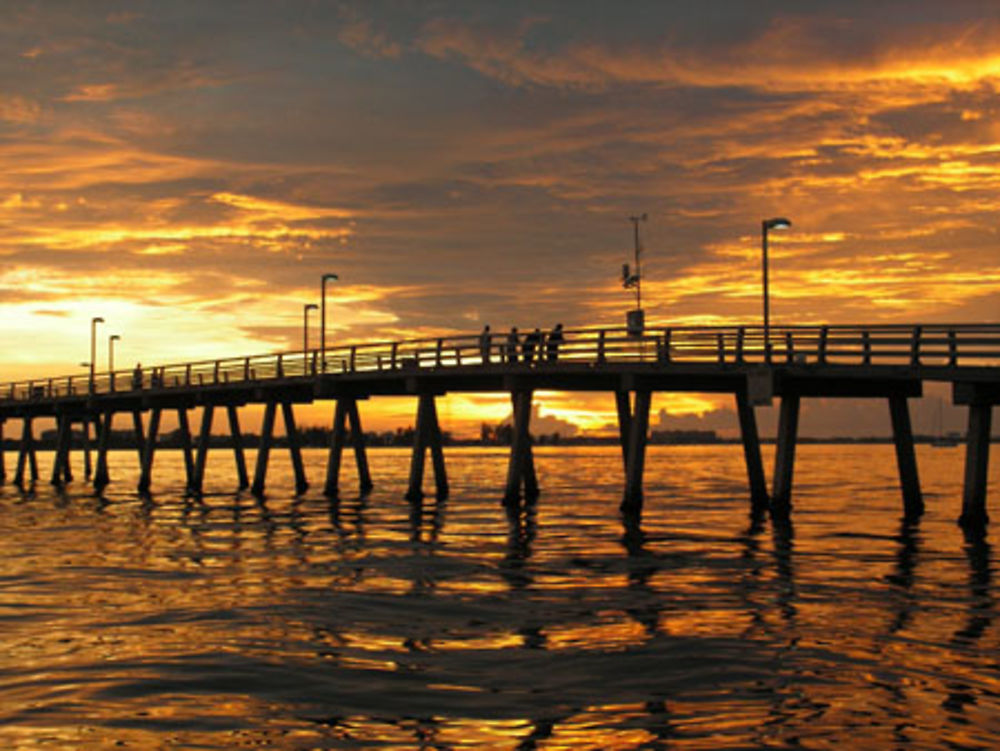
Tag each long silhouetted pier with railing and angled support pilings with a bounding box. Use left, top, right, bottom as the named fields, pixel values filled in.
left=0, top=324, right=1000, bottom=527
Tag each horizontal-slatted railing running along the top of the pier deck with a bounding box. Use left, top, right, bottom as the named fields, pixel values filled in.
left=0, top=324, right=1000, bottom=401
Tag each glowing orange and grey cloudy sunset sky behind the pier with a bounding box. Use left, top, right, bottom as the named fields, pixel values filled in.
left=0, top=0, right=1000, bottom=432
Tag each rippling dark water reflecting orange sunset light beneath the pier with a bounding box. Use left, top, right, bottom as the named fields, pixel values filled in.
left=0, top=446, right=1000, bottom=749
